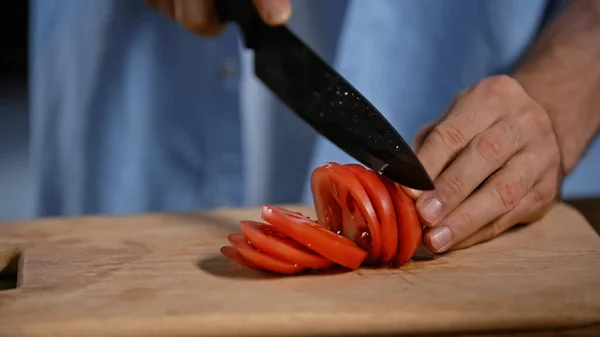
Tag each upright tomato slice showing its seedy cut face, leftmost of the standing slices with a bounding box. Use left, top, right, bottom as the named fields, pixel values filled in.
left=311, top=163, right=382, bottom=262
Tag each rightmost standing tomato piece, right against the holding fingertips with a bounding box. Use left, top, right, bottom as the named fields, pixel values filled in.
left=381, top=176, right=423, bottom=266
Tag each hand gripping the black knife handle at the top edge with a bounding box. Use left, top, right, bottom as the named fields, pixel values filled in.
left=146, top=0, right=292, bottom=36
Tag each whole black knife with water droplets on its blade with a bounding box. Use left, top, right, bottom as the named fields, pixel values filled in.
left=215, top=0, right=434, bottom=190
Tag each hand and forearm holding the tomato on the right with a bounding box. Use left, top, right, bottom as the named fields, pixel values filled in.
left=409, top=0, right=600, bottom=252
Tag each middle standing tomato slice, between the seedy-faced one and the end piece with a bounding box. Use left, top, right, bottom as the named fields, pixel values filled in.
left=344, top=164, right=398, bottom=265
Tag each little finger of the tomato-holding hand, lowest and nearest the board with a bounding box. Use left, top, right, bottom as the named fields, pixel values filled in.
left=451, top=176, right=558, bottom=250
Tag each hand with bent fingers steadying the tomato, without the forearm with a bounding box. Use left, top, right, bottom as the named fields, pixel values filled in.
left=408, top=76, right=563, bottom=253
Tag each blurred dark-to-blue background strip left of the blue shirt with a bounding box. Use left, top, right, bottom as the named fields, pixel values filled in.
left=0, top=1, right=30, bottom=222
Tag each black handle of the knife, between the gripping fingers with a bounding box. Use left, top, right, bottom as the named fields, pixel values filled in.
left=215, top=0, right=279, bottom=49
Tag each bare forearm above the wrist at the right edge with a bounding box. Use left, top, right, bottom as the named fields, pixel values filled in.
left=514, top=0, right=600, bottom=174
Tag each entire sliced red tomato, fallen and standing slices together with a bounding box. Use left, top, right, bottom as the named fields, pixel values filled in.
left=221, top=162, right=422, bottom=274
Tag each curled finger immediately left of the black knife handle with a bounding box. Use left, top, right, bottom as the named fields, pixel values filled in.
left=173, top=0, right=224, bottom=36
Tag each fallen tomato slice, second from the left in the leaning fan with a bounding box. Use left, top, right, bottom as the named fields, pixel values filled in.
left=227, top=233, right=306, bottom=274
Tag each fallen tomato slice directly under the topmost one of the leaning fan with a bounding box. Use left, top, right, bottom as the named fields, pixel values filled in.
left=240, top=221, right=333, bottom=269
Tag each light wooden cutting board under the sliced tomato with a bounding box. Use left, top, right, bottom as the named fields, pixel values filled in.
left=0, top=204, right=600, bottom=337
